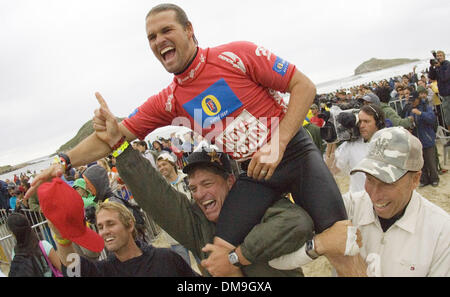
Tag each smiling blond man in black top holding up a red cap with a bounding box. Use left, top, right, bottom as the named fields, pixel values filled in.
left=38, top=178, right=198, bottom=277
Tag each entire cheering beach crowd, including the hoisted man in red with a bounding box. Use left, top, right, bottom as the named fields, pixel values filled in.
left=0, top=4, right=450, bottom=277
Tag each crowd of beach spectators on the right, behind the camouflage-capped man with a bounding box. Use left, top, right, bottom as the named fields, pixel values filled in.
left=309, top=57, right=450, bottom=190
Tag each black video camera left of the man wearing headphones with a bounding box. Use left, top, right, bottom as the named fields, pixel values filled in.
left=320, top=105, right=360, bottom=143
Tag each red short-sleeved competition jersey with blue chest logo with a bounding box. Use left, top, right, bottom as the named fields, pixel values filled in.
left=123, top=41, right=295, bottom=161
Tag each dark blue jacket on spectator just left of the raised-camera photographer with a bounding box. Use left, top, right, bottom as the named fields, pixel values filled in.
left=407, top=100, right=436, bottom=148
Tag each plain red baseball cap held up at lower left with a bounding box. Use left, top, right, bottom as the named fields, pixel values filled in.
left=38, top=177, right=104, bottom=252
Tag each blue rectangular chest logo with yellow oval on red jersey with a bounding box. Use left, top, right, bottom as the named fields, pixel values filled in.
left=183, top=78, right=242, bottom=128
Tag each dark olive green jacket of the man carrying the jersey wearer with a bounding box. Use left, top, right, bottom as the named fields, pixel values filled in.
left=116, top=148, right=313, bottom=277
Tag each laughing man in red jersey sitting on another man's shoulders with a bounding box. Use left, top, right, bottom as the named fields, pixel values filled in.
left=27, top=4, right=346, bottom=256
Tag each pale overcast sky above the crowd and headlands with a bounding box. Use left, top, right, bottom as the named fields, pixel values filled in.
left=0, top=0, right=450, bottom=166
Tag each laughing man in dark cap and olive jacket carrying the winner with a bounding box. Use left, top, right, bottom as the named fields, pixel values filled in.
left=117, top=149, right=312, bottom=276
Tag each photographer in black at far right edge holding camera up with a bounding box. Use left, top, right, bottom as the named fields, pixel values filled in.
left=428, top=51, right=450, bottom=146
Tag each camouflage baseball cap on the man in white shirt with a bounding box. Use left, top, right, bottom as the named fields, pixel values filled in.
left=351, top=127, right=423, bottom=184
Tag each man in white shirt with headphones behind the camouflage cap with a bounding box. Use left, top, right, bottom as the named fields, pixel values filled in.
left=326, top=103, right=385, bottom=192
